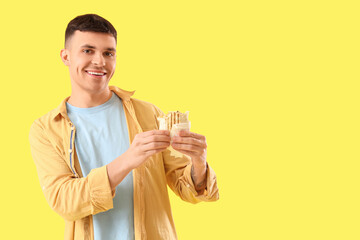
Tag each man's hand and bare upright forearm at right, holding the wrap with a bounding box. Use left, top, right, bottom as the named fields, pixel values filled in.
left=171, top=131, right=207, bottom=194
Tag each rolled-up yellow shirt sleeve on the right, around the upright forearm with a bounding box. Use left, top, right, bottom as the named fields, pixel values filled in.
left=152, top=107, right=219, bottom=203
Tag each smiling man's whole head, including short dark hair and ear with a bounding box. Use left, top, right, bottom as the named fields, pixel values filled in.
left=60, top=14, right=117, bottom=93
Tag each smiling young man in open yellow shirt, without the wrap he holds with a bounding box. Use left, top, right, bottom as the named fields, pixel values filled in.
left=30, top=14, right=219, bottom=240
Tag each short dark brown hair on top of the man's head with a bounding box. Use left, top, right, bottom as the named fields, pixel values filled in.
left=65, top=14, right=117, bottom=46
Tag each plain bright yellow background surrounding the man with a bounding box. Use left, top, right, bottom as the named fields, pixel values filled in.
left=0, top=0, right=360, bottom=240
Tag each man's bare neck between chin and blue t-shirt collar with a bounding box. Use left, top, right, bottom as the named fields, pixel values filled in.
left=68, top=87, right=112, bottom=108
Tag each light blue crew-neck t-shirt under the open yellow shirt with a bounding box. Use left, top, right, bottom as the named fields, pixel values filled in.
left=66, top=93, right=134, bottom=240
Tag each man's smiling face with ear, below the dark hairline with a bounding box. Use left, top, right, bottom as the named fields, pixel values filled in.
left=60, top=31, right=116, bottom=93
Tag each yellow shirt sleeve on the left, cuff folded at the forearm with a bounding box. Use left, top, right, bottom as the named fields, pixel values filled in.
left=29, top=121, right=115, bottom=221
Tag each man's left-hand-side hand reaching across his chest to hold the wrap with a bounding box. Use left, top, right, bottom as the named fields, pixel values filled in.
left=126, top=130, right=171, bottom=168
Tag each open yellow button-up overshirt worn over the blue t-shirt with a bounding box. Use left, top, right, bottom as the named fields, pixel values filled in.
left=29, top=86, right=219, bottom=240
